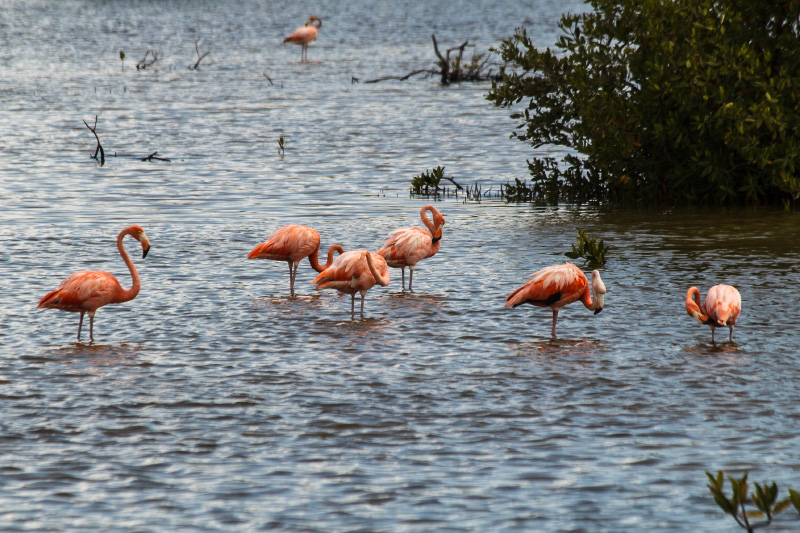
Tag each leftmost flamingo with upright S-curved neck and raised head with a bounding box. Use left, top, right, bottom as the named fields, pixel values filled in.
left=36, top=225, right=150, bottom=342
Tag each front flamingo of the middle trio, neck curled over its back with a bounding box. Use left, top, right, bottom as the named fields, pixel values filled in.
left=311, top=250, right=389, bottom=320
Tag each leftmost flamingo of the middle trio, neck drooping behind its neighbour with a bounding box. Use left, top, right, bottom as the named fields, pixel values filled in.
left=247, top=224, right=344, bottom=296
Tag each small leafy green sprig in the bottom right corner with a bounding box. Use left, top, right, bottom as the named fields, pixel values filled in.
left=706, top=470, right=800, bottom=533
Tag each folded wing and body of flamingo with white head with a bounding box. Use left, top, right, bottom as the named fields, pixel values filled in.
left=505, top=263, right=589, bottom=309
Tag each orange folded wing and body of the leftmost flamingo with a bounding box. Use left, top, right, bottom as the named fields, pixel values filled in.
left=37, top=271, right=123, bottom=312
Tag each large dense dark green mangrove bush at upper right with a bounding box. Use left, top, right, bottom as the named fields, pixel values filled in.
left=487, top=0, right=800, bottom=206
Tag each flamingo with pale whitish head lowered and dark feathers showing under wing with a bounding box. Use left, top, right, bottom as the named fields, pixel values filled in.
left=505, top=263, right=606, bottom=337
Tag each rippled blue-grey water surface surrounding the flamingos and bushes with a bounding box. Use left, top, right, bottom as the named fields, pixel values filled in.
left=0, top=0, right=800, bottom=531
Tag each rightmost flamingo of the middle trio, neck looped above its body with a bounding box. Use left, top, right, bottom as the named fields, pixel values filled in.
left=378, top=205, right=444, bottom=291
